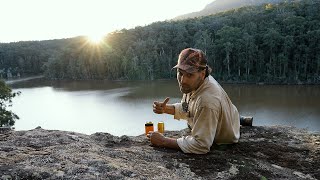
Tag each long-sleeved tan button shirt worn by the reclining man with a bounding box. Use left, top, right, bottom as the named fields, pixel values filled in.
left=174, top=76, right=240, bottom=154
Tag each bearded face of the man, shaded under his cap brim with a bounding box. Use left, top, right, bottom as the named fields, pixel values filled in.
left=177, top=69, right=205, bottom=94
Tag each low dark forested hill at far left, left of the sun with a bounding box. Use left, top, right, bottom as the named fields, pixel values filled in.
left=0, top=39, right=73, bottom=78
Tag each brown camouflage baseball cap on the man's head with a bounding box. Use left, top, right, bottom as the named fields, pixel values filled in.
left=173, top=48, right=207, bottom=73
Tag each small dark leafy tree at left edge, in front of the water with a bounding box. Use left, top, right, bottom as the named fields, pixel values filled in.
left=0, top=80, right=20, bottom=127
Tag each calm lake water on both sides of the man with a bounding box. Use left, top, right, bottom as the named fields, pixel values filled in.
left=10, top=79, right=320, bottom=136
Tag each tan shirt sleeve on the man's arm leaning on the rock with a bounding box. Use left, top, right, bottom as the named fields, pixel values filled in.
left=177, top=107, right=218, bottom=154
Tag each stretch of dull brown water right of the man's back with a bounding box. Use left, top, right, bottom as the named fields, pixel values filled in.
left=225, top=85, right=320, bottom=131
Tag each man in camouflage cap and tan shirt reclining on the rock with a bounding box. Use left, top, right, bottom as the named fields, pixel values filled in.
left=148, top=48, right=240, bottom=154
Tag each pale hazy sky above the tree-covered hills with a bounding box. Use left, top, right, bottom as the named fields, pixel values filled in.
left=0, top=0, right=214, bottom=42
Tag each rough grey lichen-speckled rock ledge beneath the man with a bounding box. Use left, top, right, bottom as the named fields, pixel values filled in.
left=0, top=126, right=320, bottom=180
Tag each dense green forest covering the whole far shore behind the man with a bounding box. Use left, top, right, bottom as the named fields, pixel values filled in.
left=0, top=0, right=320, bottom=84
